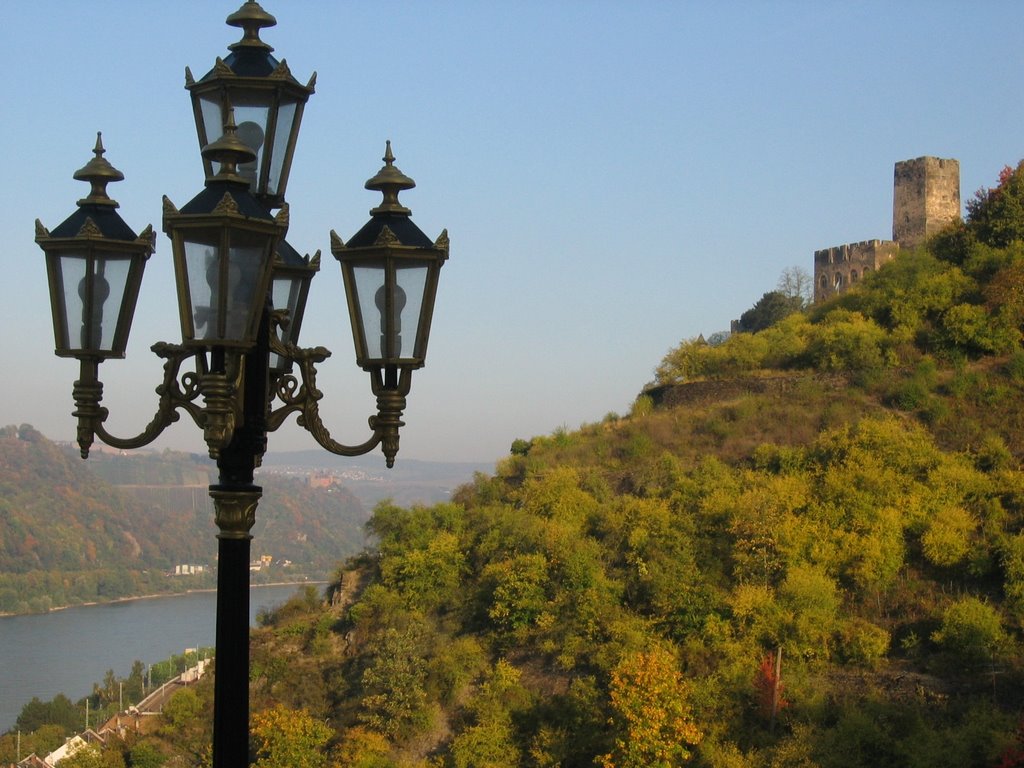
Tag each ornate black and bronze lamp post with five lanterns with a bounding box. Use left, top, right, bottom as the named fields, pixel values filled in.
left=36, top=0, right=449, bottom=768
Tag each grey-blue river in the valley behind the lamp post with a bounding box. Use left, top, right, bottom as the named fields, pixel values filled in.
left=0, top=585, right=323, bottom=733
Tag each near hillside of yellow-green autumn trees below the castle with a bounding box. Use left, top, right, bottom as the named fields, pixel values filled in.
left=14, top=159, right=1024, bottom=768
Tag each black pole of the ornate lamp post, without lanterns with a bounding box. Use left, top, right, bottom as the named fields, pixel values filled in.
left=210, top=309, right=269, bottom=768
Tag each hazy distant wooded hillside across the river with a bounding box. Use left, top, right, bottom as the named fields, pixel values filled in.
left=0, top=425, right=366, bottom=613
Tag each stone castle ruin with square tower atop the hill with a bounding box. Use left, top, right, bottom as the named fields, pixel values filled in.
left=814, top=157, right=961, bottom=302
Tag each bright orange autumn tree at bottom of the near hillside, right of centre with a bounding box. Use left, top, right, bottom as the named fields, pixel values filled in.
left=600, top=647, right=702, bottom=768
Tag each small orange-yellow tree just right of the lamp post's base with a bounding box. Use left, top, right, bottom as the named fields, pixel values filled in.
left=252, top=705, right=334, bottom=768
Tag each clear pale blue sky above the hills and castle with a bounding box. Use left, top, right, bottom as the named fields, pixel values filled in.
left=6, top=0, right=1024, bottom=464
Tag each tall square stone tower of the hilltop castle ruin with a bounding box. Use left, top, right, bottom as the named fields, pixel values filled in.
left=893, top=158, right=961, bottom=249
